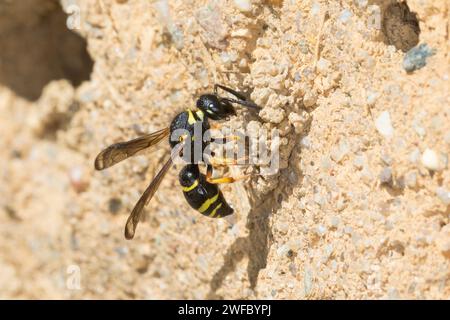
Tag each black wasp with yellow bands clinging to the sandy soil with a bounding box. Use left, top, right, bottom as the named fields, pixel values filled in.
left=95, top=84, right=260, bottom=239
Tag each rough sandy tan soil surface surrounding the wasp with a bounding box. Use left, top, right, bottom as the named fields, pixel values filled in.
left=0, top=0, right=450, bottom=299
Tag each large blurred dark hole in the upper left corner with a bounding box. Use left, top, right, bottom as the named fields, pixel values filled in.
left=0, top=0, right=93, bottom=101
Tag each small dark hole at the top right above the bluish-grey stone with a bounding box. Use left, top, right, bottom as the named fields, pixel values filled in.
left=372, top=0, right=420, bottom=52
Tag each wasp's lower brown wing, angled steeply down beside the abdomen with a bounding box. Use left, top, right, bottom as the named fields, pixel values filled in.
left=125, top=157, right=172, bottom=240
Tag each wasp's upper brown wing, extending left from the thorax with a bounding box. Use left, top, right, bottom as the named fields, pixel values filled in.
left=95, top=128, right=170, bottom=170
